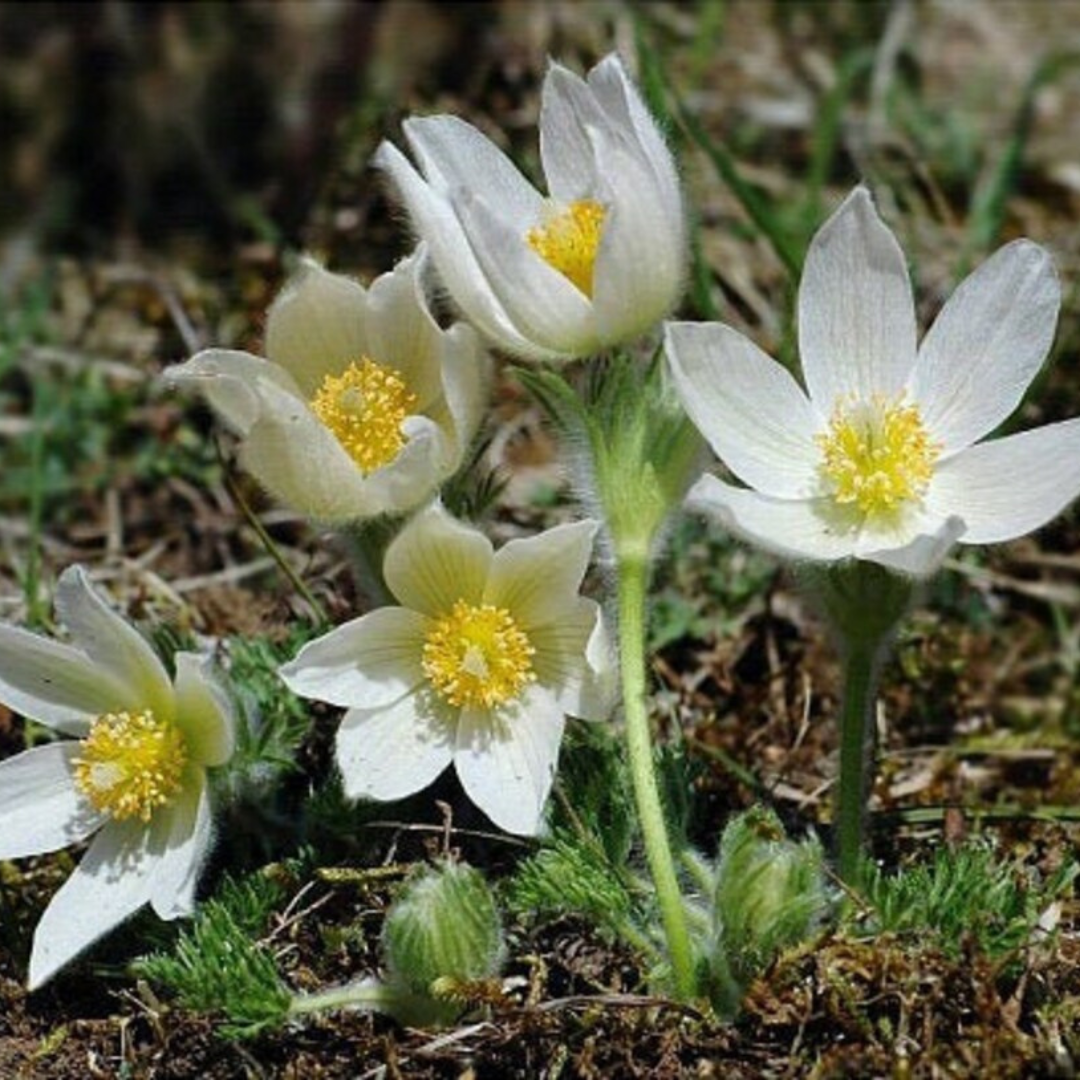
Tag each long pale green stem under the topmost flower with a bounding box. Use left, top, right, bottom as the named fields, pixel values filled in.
left=618, top=554, right=697, bottom=1001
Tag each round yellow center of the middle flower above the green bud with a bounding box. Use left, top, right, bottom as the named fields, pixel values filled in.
left=421, top=600, right=536, bottom=708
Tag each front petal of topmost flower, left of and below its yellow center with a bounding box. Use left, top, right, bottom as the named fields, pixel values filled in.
left=451, top=188, right=597, bottom=360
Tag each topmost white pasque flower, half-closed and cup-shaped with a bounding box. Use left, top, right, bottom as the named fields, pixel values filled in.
left=375, top=53, right=687, bottom=360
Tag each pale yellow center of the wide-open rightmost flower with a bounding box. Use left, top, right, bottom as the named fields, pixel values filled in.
left=815, top=395, right=941, bottom=515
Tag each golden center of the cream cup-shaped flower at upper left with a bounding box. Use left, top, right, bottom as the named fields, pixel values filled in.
left=311, top=356, right=417, bottom=473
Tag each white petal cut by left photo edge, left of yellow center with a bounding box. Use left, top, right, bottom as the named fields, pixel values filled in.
left=0, top=742, right=105, bottom=859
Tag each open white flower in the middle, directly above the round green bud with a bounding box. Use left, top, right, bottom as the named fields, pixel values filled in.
left=280, top=503, right=611, bottom=834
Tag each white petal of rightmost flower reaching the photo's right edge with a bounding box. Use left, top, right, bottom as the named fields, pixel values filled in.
left=926, top=419, right=1080, bottom=543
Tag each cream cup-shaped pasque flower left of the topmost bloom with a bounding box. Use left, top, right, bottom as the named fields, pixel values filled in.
left=166, top=247, right=487, bottom=524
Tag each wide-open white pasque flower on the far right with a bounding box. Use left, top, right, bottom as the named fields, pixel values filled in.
left=665, top=187, right=1080, bottom=577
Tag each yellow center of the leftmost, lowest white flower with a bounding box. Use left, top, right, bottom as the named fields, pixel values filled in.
left=75, top=708, right=188, bottom=822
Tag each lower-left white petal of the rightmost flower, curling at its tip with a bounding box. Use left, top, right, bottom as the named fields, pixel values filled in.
left=686, top=475, right=855, bottom=562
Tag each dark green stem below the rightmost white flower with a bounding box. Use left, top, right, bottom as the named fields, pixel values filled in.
left=836, top=642, right=878, bottom=886
